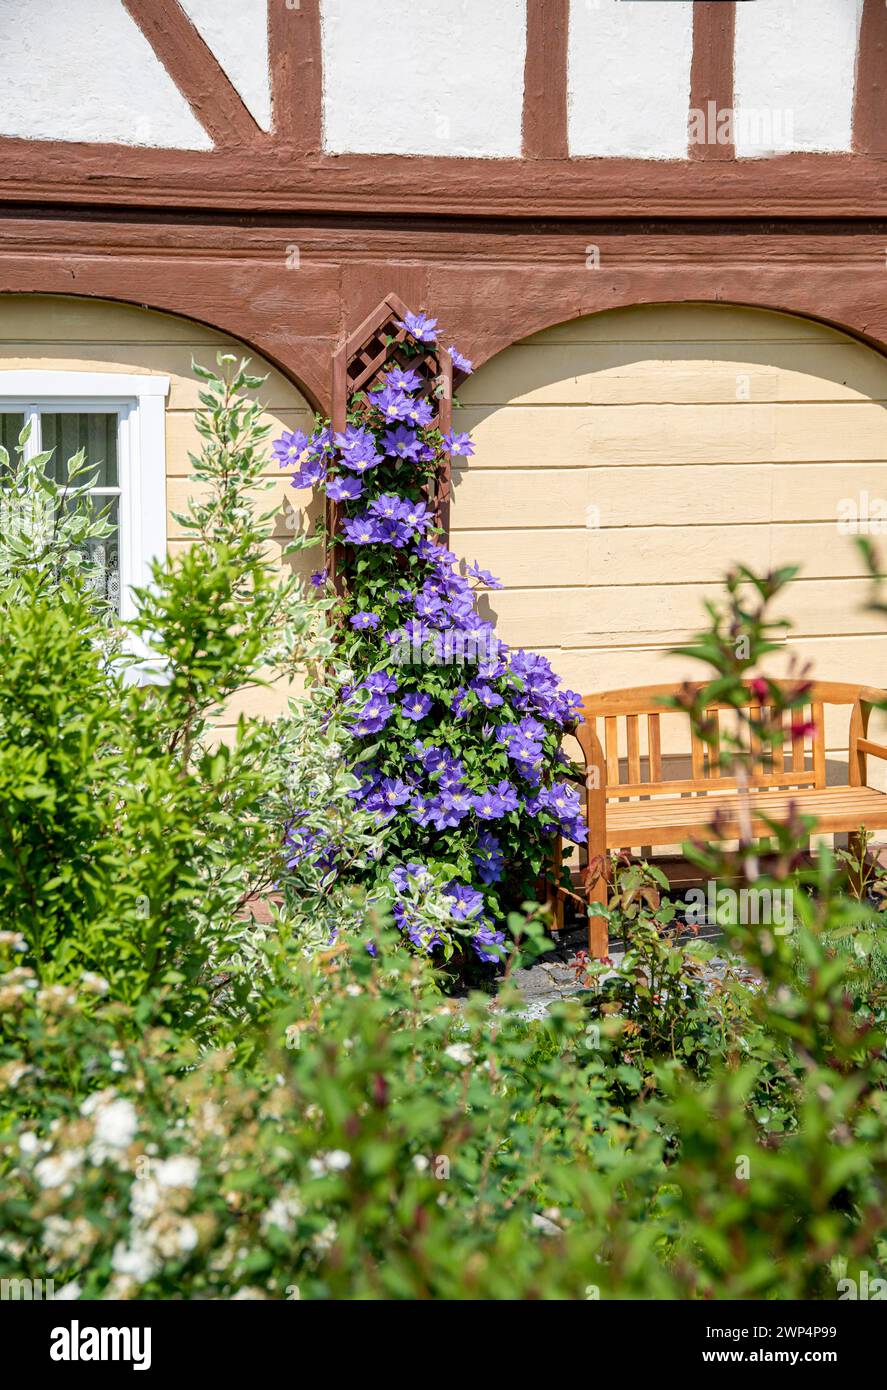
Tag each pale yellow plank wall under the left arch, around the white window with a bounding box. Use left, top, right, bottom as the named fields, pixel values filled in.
left=0, top=295, right=316, bottom=728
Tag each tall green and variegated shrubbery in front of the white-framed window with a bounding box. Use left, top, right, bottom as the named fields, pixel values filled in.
left=0, top=359, right=378, bottom=1036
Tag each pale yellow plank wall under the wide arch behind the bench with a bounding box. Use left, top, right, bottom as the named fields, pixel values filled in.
left=452, top=304, right=887, bottom=771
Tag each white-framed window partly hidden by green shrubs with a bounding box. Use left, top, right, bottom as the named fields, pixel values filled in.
left=0, top=370, right=170, bottom=619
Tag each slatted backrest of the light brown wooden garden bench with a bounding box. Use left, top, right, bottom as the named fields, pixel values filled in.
left=577, top=681, right=887, bottom=799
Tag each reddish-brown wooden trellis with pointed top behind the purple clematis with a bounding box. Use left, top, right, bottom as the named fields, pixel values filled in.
left=327, top=293, right=464, bottom=580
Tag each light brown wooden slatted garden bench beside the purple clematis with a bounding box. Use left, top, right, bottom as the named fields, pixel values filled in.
left=558, top=681, right=887, bottom=958
